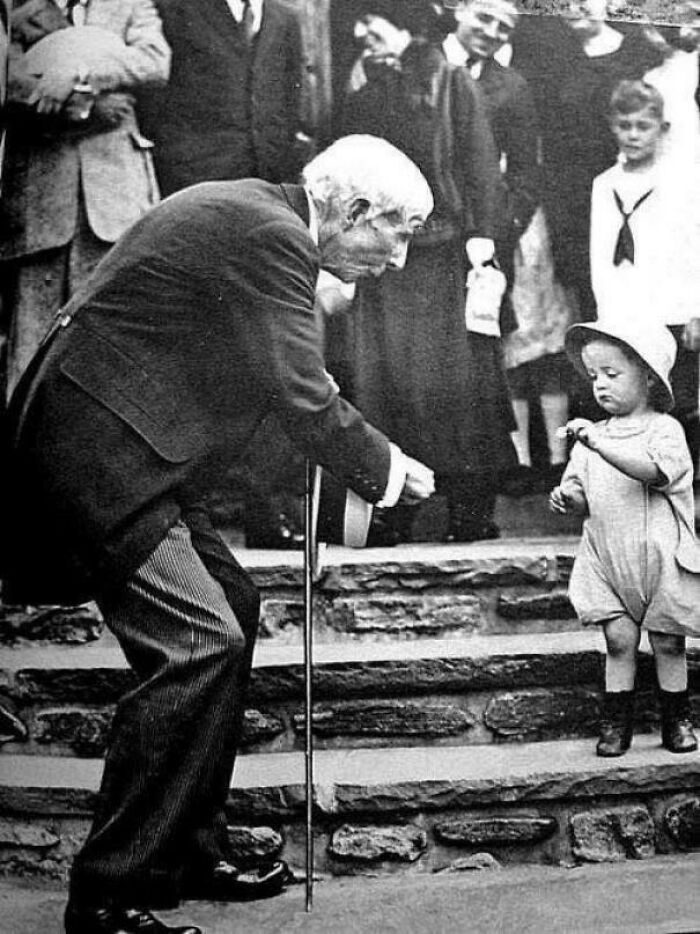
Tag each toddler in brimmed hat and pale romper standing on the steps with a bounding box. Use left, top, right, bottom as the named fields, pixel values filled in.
left=550, top=316, right=700, bottom=756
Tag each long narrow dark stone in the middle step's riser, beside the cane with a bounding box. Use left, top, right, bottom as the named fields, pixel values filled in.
left=294, top=700, right=476, bottom=736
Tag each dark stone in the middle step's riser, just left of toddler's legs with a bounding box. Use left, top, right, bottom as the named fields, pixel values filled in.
left=484, top=687, right=599, bottom=739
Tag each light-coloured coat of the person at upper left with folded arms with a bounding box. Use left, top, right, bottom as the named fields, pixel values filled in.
left=0, top=0, right=170, bottom=260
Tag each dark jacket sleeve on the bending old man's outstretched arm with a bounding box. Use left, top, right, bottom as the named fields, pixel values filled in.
left=211, top=221, right=391, bottom=502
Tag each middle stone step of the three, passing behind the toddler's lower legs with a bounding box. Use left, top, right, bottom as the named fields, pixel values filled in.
left=0, top=631, right=700, bottom=757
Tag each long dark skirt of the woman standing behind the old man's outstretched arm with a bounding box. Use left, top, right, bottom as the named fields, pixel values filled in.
left=349, top=240, right=516, bottom=475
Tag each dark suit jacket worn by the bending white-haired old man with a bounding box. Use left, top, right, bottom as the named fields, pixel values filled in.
left=2, top=180, right=390, bottom=603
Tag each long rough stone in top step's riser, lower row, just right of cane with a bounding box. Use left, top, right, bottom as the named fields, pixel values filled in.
left=329, top=594, right=484, bottom=635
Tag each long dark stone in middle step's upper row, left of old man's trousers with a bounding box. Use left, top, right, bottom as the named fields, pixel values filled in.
left=11, top=668, right=136, bottom=705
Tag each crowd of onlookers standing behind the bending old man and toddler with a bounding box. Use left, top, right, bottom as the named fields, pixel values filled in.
left=0, top=0, right=700, bottom=547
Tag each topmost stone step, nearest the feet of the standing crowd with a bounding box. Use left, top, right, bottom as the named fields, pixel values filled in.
left=0, top=537, right=577, bottom=644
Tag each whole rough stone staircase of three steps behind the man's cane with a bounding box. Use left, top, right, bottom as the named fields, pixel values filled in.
left=0, top=537, right=700, bottom=877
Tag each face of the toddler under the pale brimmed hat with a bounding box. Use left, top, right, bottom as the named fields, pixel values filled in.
left=581, top=340, right=652, bottom=415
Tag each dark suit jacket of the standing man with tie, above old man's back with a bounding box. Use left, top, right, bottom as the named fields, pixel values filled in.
left=144, top=0, right=303, bottom=195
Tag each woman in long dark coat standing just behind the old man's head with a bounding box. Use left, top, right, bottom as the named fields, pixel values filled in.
left=343, top=0, right=515, bottom=541
